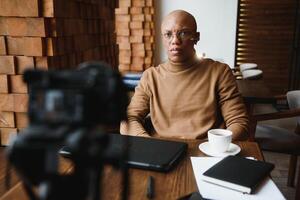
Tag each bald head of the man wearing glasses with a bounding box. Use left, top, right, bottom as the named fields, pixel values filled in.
left=161, top=10, right=199, bottom=62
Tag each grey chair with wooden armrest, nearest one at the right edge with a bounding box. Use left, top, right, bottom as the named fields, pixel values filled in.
left=250, top=90, right=300, bottom=188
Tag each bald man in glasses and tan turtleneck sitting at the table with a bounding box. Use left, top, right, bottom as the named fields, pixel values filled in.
left=120, top=10, right=248, bottom=140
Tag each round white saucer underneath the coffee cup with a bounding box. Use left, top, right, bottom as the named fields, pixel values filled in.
left=199, top=142, right=241, bottom=157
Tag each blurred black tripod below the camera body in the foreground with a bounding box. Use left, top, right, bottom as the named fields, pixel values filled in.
left=8, top=126, right=128, bottom=200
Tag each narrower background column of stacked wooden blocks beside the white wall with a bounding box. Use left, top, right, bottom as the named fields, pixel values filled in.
left=115, top=0, right=155, bottom=72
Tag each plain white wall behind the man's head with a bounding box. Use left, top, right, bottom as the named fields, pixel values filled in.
left=155, top=0, right=237, bottom=67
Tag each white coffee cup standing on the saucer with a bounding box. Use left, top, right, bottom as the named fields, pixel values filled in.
left=207, top=129, right=232, bottom=153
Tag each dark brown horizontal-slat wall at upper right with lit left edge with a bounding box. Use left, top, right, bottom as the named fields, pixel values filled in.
left=235, top=0, right=297, bottom=94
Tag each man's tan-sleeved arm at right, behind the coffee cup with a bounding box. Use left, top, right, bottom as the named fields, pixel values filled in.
left=218, top=65, right=249, bottom=140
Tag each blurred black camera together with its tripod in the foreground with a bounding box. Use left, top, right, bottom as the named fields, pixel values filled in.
left=7, top=62, right=128, bottom=200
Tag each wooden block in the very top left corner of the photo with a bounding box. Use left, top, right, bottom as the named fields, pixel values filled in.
left=0, top=0, right=39, bottom=17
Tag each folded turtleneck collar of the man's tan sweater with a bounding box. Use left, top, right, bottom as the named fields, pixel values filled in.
left=166, top=54, right=199, bottom=72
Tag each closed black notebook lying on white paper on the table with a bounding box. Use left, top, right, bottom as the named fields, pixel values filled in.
left=203, top=156, right=274, bottom=194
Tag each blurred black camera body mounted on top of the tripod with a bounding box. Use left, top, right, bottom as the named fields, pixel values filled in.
left=24, top=62, right=128, bottom=127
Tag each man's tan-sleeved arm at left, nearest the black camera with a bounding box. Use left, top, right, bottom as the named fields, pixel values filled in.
left=120, top=72, right=150, bottom=136
